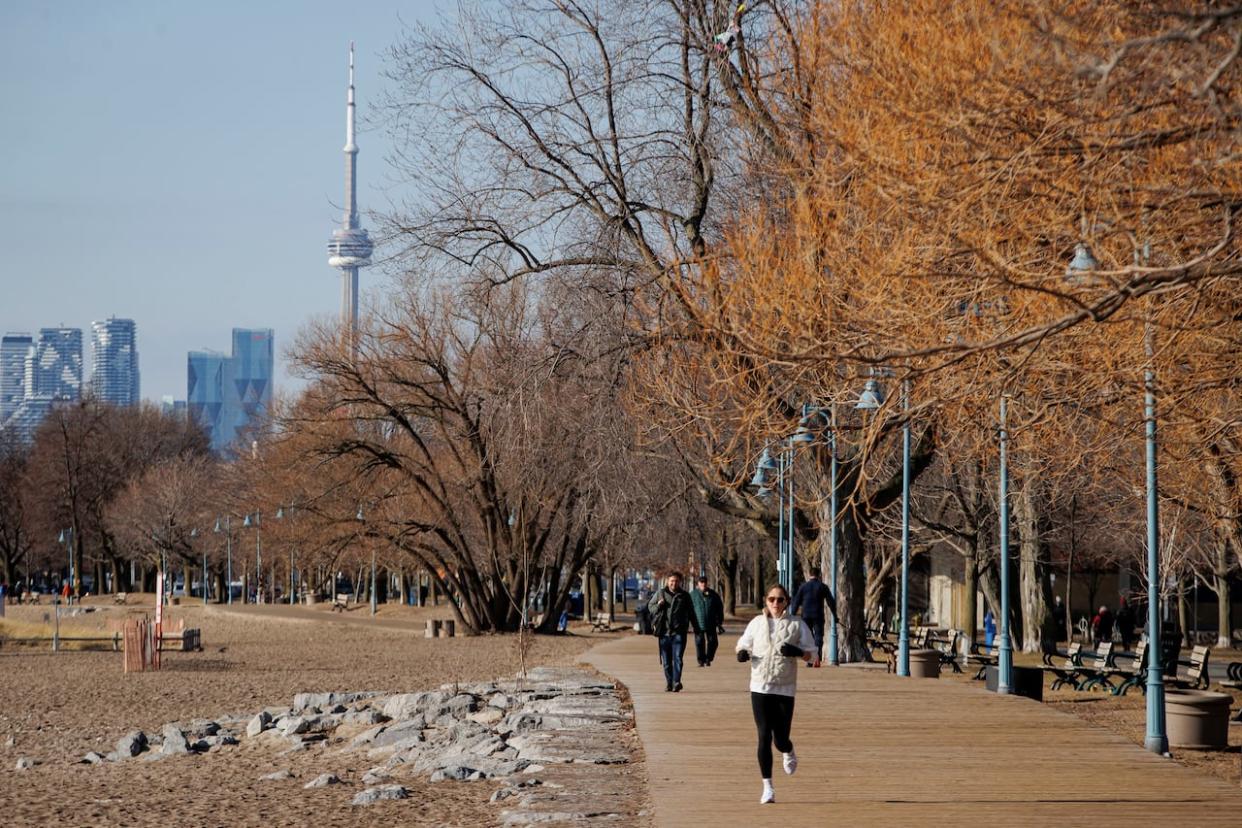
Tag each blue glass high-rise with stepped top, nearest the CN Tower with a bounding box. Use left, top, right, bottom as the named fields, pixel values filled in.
left=185, top=328, right=274, bottom=453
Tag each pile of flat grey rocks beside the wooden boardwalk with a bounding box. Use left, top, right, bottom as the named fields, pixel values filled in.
left=82, top=668, right=631, bottom=824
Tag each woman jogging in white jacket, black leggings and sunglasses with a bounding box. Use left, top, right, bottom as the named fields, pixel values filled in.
left=737, top=583, right=815, bottom=804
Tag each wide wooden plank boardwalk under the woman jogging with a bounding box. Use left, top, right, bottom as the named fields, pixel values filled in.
left=586, top=636, right=1242, bottom=828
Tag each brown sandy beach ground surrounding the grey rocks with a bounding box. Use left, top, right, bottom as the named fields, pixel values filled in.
left=0, top=596, right=646, bottom=827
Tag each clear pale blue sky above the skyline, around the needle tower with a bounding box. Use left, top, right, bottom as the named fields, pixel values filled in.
left=0, top=0, right=433, bottom=400
